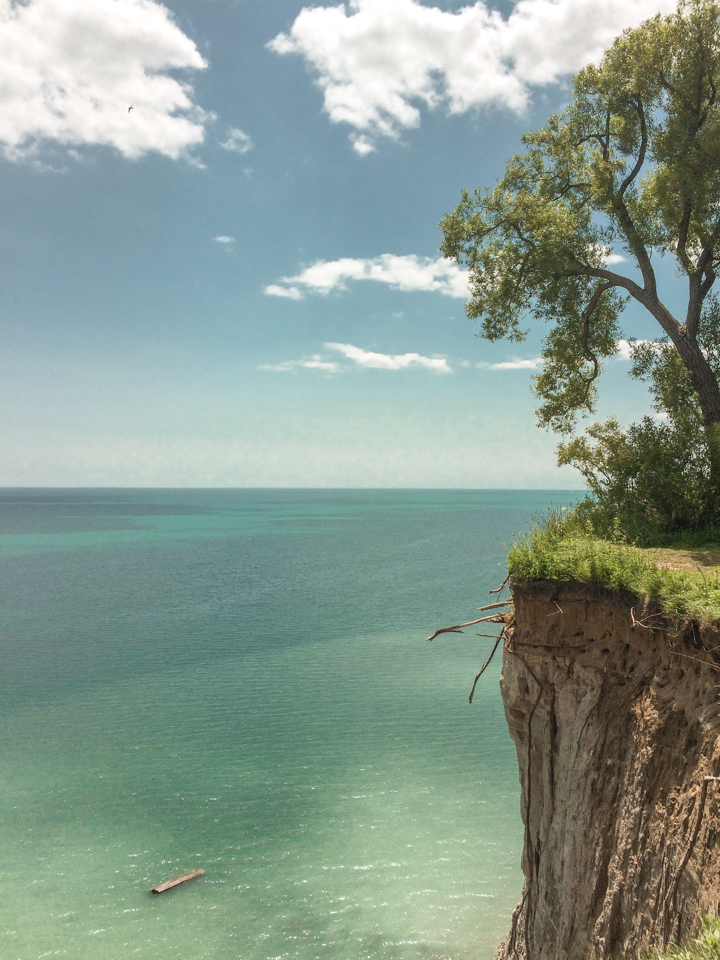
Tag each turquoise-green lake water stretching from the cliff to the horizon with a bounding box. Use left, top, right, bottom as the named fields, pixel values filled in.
left=0, top=490, right=572, bottom=960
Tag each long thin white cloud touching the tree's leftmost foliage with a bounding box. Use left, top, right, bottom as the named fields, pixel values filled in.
left=265, top=253, right=468, bottom=300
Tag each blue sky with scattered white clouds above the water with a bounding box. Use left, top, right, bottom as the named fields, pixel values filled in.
left=0, top=0, right=681, bottom=489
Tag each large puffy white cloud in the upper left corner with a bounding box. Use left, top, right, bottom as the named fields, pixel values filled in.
left=0, top=0, right=214, bottom=160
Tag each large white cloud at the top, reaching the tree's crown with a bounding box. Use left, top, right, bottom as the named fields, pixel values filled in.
left=268, top=0, right=675, bottom=155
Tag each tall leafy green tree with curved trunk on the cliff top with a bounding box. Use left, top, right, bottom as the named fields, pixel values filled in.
left=441, top=0, right=720, bottom=517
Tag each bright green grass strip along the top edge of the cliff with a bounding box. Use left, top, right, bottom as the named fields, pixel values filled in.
left=508, top=512, right=720, bottom=628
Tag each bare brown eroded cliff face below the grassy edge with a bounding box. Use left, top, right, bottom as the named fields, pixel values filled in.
left=497, top=583, right=720, bottom=960
